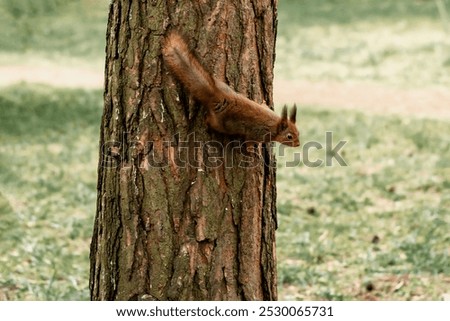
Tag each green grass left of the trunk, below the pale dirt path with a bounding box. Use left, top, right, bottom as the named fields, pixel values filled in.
left=0, top=86, right=102, bottom=300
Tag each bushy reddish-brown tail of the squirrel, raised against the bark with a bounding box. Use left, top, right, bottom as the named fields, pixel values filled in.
left=162, top=32, right=218, bottom=105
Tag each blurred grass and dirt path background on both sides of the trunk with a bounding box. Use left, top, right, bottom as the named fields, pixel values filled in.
left=0, top=0, right=450, bottom=300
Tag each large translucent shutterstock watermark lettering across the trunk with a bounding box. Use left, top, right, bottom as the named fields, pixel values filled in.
left=101, top=132, right=348, bottom=169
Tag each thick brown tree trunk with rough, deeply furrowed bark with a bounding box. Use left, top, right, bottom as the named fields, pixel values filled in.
left=90, top=0, right=277, bottom=300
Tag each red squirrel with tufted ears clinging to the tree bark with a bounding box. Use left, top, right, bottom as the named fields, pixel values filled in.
left=162, top=32, right=300, bottom=147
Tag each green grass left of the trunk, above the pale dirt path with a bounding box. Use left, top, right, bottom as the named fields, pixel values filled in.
left=0, top=0, right=109, bottom=60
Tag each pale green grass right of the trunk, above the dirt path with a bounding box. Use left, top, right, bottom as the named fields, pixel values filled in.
left=275, top=0, right=450, bottom=87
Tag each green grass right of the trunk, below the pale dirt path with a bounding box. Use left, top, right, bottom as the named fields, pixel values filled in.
left=277, top=107, right=450, bottom=300
